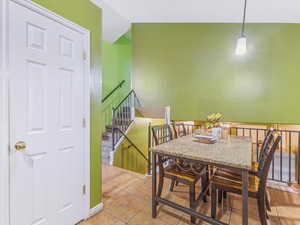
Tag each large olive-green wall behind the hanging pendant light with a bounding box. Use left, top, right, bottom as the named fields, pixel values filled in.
left=132, top=23, right=300, bottom=124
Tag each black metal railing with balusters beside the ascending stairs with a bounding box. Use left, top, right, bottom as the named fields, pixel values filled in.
left=112, top=90, right=141, bottom=151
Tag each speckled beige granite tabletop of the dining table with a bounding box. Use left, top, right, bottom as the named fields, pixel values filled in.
left=150, top=135, right=252, bottom=170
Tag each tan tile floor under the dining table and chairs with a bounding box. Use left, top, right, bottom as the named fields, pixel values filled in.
left=80, top=166, right=300, bottom=225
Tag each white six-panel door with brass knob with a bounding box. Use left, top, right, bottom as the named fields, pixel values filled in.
left=9, top=1, right=84, bottom=225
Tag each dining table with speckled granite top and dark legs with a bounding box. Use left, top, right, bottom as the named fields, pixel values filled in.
left=149, top=135, right=252, bottom=225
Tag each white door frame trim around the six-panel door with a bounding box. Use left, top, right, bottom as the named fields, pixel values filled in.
left=0, top=0, right=90, bottom=224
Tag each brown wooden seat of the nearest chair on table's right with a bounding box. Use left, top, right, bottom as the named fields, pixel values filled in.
left=212, top=170, right=260, bottom=193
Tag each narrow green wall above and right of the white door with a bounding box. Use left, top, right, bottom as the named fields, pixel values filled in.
left=34, top=0, right=102, bottom=207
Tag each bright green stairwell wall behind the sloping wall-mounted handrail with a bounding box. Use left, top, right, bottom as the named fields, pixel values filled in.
left=102, top=34, right=132, bottom=131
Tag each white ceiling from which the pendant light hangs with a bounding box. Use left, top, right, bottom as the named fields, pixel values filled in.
left=92, top=0, right=300, bottom=42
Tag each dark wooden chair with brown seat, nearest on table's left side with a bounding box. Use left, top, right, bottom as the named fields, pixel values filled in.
left=151, top=124, right=208, bottom=223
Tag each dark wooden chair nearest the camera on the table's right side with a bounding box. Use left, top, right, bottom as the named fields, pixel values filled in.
left=211, top=134, right=281, bottom=225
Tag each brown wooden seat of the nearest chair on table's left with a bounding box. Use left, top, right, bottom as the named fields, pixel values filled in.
left=164, top=166, right=205, bottom=182
